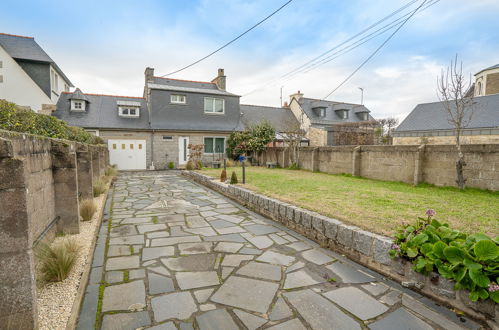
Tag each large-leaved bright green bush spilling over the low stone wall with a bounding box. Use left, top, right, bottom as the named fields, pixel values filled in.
left=390, top=210, right=499, bottom=303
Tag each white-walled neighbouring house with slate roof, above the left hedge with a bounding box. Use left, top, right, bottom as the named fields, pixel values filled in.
left=0, top=33, right=73, bottom=113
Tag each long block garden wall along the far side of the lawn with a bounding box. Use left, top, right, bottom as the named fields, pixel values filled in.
left=256, top=144, right=499, bottom=191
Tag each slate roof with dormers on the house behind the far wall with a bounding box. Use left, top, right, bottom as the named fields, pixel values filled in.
left=299, top=97, right=374, bottom=125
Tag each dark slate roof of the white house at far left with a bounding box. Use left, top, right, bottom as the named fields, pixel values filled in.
left=0, top=33, right=74, bottom=87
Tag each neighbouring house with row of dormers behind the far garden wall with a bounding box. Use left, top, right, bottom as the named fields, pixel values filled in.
left=289, top=91, right=374, bottom=146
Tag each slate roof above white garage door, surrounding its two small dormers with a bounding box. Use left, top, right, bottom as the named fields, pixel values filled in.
left=54, top=92, right=149, bottom=130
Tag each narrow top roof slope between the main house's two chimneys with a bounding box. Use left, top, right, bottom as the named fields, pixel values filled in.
left=148, top=77, right=237, bottom=96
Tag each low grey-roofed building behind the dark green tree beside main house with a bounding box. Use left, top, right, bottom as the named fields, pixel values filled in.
left=241, top=104, right=309, bottom=146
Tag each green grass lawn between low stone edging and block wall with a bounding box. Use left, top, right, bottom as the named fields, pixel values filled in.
left=200, top=167, right=499, bottom=236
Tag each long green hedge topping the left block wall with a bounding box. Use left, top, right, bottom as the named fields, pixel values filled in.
left=0, top=100, right=103, bottom=144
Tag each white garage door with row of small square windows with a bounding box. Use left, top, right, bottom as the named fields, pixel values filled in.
left=107, top=140, right=146, bottom=170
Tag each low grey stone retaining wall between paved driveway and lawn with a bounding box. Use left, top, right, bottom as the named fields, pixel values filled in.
left=182, top=171, right=499, bottom=327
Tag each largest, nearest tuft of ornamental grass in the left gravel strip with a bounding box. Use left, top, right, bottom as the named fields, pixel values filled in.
left=35, top=239, right=79, bottom=282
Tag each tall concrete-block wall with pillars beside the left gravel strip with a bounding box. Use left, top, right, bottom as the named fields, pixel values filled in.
left=0, top=131, right=108, bottom=329
